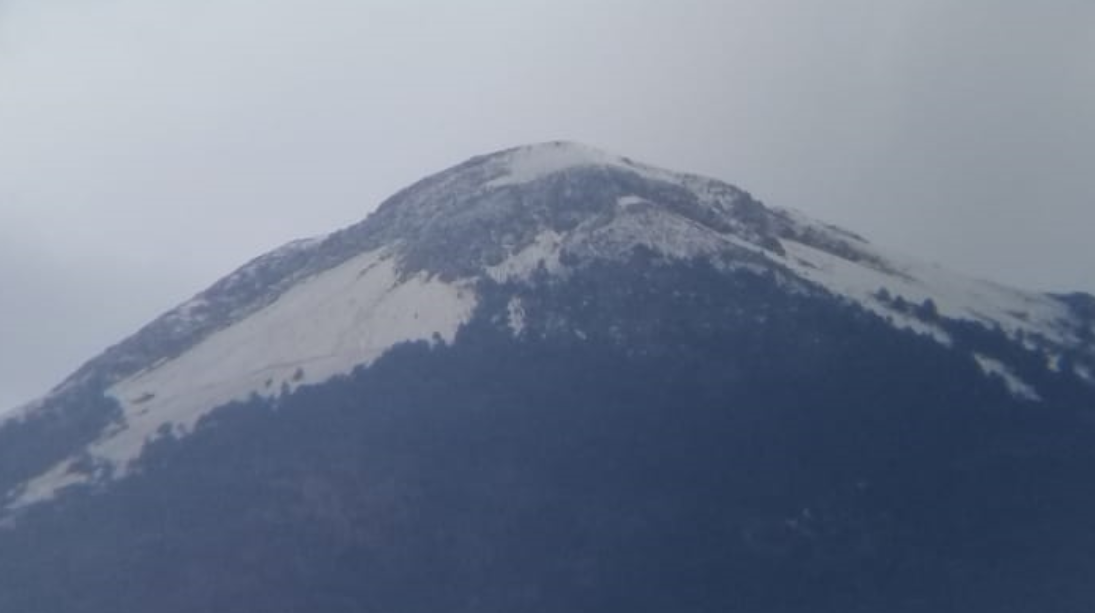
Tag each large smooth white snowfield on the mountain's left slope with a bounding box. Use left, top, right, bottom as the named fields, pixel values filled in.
left=8, top=252, right=476, bottom=506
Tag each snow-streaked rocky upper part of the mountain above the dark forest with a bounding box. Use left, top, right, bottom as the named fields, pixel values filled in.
left=2, top=142, right=1095, bottom=506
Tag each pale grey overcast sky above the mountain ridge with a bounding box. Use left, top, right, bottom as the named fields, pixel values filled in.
left=0, top=0, right=1095, bottom=407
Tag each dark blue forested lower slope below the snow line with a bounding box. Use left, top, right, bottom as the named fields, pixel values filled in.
left=0, top=256, right=1095, bottom=613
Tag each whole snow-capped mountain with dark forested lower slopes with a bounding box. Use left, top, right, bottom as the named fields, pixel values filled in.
left=6, top=142, right=1095, bottom=613
